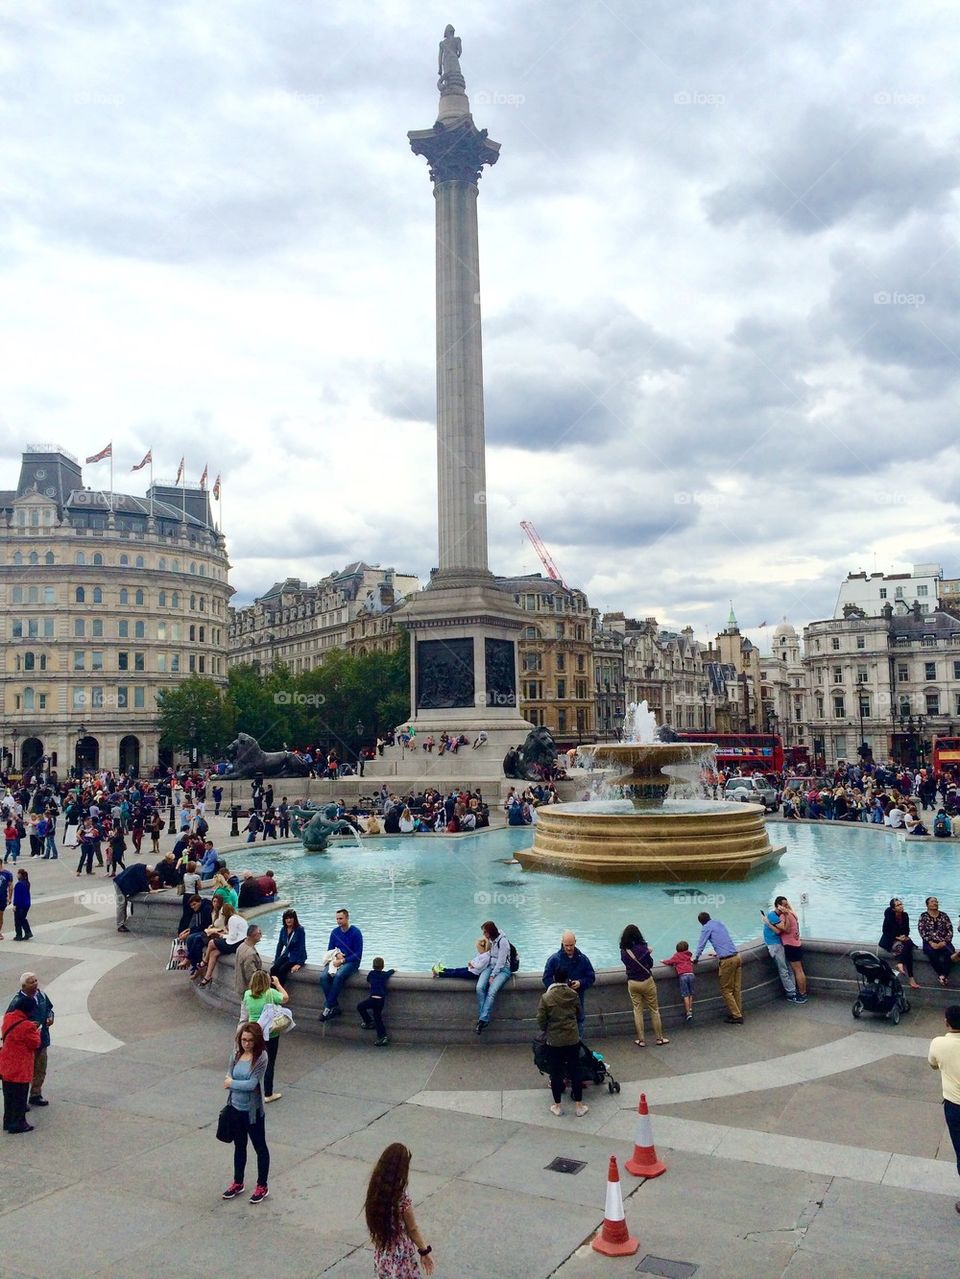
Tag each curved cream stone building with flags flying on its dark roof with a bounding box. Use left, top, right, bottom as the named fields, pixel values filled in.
left=0, top=445, right=233, bottom=776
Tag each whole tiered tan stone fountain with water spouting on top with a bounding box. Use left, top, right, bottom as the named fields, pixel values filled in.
left=516, top=702, right=784, bottom=888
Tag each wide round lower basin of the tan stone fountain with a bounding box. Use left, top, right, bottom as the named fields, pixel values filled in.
left=515, top=799, right=784, bottom=883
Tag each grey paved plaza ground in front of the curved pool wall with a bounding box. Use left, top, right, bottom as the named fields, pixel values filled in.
left=0, top=822, right=960, bottom=1279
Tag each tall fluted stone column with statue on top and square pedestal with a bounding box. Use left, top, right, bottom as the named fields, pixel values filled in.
left=401, top=27, right=530, bottom=746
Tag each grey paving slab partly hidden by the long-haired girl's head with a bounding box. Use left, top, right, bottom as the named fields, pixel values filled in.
left=331, top=1105, right=518, bottom=1177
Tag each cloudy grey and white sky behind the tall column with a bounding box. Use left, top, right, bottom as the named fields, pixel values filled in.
left=0, top=0, right=960, bottom=647
